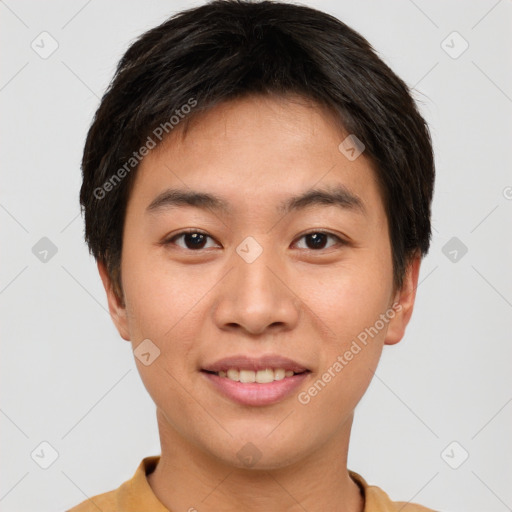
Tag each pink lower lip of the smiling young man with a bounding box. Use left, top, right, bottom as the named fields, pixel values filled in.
left=201, top=372, right=309, bottom=406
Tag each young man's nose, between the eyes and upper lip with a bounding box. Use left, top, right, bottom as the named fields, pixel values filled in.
left=213, top=240, right=301, bottom=335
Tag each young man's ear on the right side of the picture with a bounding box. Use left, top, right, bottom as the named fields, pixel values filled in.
left=384, top=252, right=421, bottom=345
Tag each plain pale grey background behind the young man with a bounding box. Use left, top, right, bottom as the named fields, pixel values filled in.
left=0, top=0, right=512, bottom=512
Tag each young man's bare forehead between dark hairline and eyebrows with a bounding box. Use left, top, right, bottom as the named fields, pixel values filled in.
left=129, top=96, right=382, bottom=221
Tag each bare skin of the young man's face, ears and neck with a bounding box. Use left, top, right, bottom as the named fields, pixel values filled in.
left=98, top=96, right=421, bottom=512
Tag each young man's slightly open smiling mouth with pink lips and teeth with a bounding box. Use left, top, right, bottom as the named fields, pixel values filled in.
left=201, top=356, right=311, bottom=406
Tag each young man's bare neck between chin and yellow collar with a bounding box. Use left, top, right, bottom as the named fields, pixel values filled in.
left=148, top=411, right=364, bottom=512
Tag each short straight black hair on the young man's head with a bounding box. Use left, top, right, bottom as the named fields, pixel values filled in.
left=80, top=0, right=435, bottom=300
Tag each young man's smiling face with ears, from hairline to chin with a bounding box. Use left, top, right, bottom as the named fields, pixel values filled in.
left=100, top=97, right=419, bottom=468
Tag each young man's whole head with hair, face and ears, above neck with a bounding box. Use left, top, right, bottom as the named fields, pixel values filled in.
left=80, top=0, right=434, bottom=467
